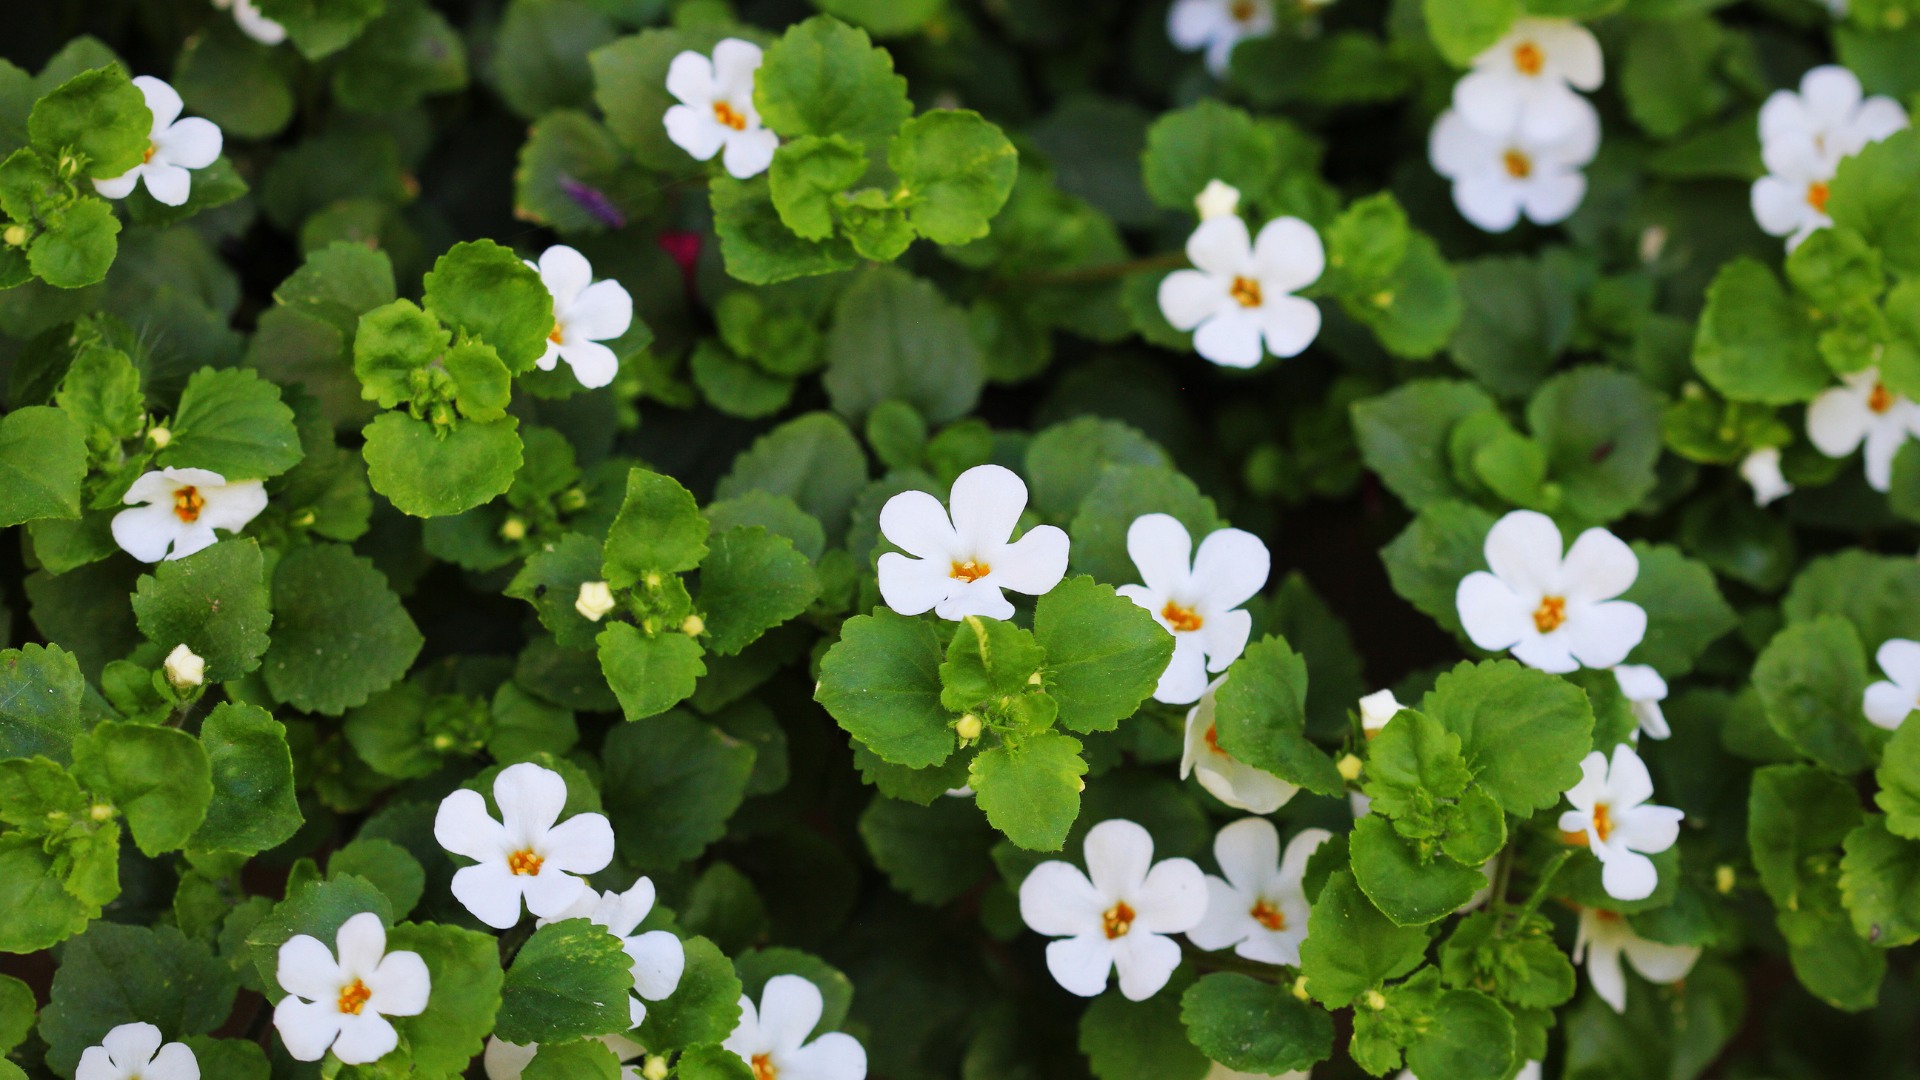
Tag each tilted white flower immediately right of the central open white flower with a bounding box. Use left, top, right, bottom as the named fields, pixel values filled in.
left=1114, top=513, right=1271, bottom=705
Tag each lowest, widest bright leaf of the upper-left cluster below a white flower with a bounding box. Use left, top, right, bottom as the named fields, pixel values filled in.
left=361, top=411, right=520, bottom=517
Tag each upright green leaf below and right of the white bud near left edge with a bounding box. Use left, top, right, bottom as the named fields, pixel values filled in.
left=188, top=701, right=303, bottom=855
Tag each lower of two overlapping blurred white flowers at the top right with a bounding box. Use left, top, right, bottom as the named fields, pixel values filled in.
left=1427, top=96, right=1599, bottom=233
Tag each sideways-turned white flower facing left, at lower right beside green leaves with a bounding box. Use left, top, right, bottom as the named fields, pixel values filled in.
left=1559, top=742, right=1686, bottom=899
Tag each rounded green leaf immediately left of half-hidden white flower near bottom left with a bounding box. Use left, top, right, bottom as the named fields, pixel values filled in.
left=493, top=919, right=634, bottom=1043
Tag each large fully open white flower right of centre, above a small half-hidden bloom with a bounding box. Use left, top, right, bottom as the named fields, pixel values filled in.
left=1453, top=509, right=1647, bottom=673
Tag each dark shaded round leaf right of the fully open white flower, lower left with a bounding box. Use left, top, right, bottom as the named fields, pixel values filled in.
left=601, top=709, right=755, bottom=871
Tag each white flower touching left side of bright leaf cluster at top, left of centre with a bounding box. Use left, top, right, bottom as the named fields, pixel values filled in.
left=666, top=38, right=780, bottom=181
